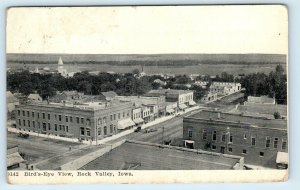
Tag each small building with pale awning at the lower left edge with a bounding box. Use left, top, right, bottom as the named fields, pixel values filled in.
left=6, top=143, right=25, bottom=170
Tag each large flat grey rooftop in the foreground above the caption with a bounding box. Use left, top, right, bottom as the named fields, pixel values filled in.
left=80, top=142, right=241, bottom=170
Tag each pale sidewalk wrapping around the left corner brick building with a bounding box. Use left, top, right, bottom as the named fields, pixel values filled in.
left=7, top=105, right=201, bottom=145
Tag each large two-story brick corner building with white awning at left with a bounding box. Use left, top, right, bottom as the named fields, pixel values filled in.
left=16, top=102, right=135, bottom=141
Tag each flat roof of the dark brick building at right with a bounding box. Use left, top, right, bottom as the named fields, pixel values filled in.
left=186, top=110, right=287, bottom=130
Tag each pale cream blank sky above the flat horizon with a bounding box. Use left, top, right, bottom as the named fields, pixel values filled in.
left=6, top=5, right=288, bottom=54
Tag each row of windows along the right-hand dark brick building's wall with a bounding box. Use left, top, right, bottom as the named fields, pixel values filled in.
left=188, top=129, right=287, bottom=150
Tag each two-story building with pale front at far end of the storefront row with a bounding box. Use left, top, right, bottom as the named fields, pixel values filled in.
left=146, top=89, right=196, bottom=110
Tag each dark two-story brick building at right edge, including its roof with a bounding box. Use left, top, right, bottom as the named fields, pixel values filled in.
left=183, top=111, right=288, bottom=168
